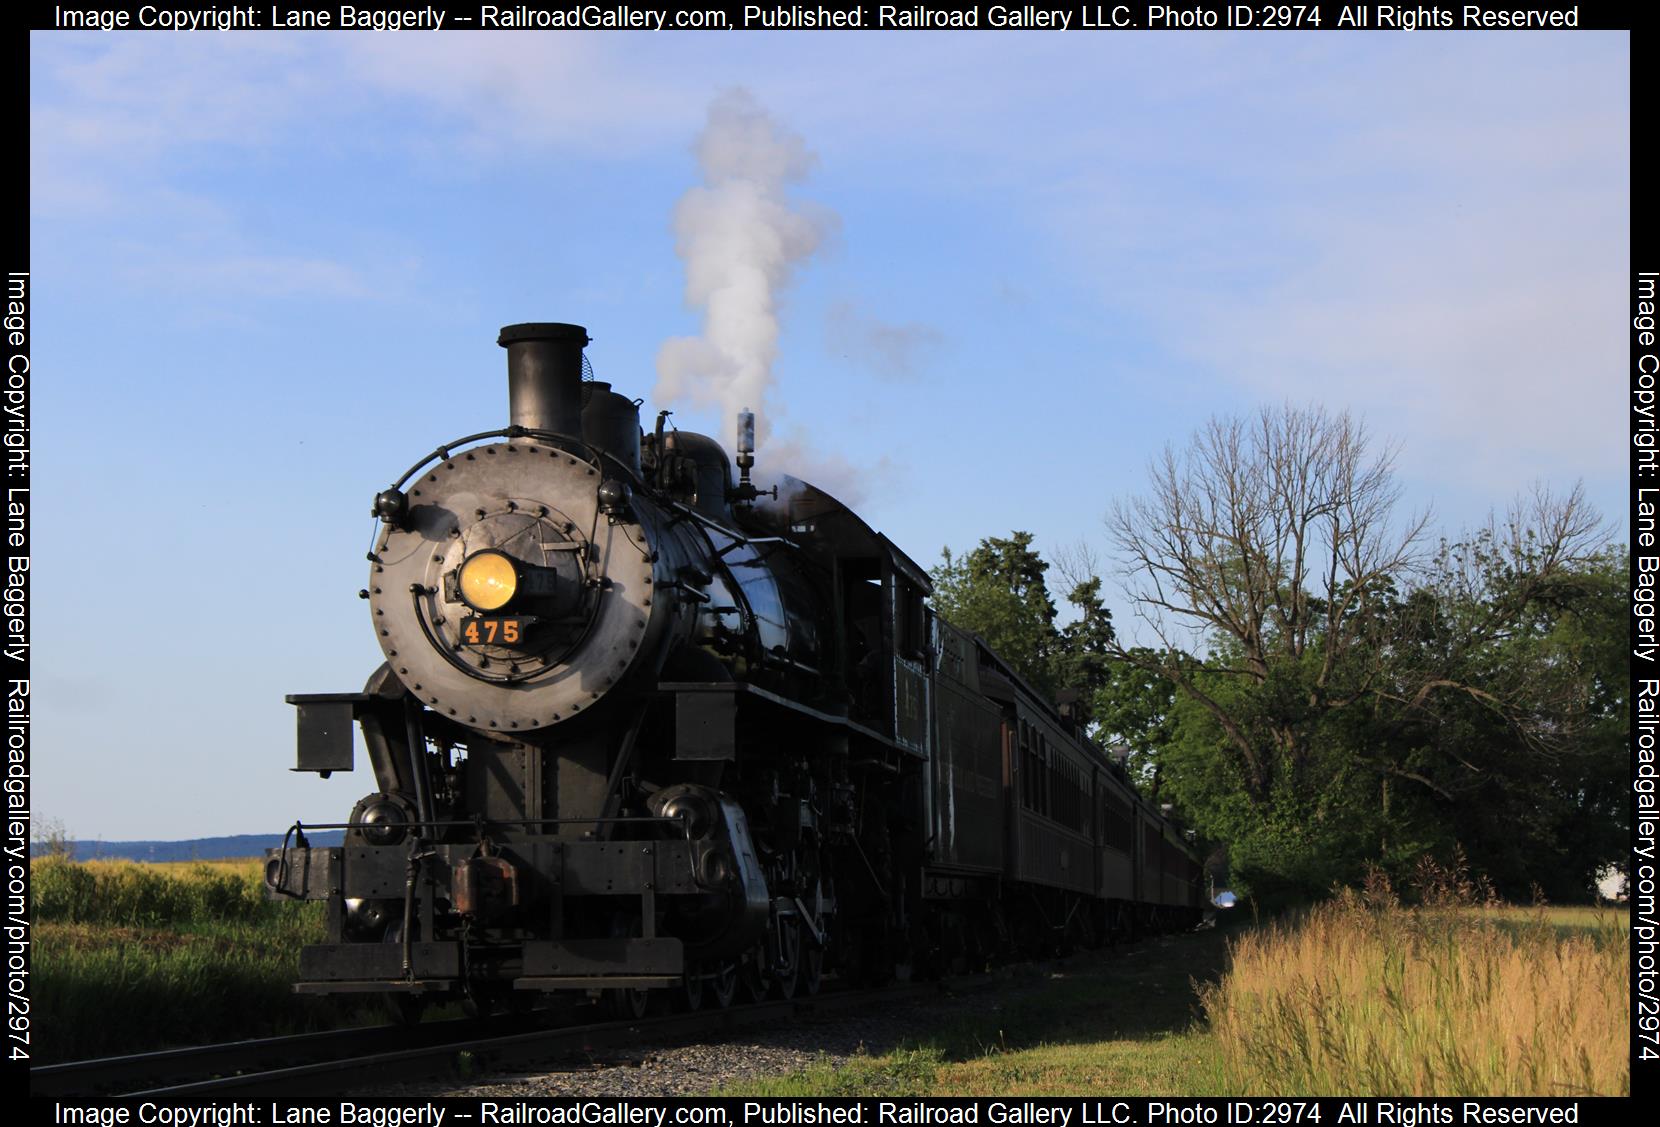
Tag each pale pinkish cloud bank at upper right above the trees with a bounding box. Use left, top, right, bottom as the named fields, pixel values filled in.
left=1047, top=37, right=1630, bottom=493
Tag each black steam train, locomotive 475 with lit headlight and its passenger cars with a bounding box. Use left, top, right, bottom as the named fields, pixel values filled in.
left=266, top=324, right=1202, bottom=1016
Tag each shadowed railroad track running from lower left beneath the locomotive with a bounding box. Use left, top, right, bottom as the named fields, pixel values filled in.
left=30, top=976, right=956, bottom=1099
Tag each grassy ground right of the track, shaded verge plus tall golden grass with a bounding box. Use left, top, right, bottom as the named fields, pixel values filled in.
left=729, top=888, right=1630, bottom=1095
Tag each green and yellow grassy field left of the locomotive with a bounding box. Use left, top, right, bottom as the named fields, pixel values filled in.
left=32, top=856, right=360, bottom=1064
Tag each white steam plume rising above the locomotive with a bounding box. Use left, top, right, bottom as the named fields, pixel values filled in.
left=654, top=90, right=835, bottom=448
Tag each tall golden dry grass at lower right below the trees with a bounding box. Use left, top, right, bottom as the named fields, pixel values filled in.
left=1200, top=870, right=1630, bottom=1095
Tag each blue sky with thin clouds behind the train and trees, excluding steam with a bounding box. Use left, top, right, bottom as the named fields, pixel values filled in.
left=30, top=32, right=1630, bottom=838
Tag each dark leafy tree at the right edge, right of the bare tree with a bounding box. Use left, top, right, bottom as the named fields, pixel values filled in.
left=1366, top=529, right=1630, bottom=898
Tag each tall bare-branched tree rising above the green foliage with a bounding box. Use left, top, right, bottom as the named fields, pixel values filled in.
left=1107, top=407, right=1426, bottom=803
